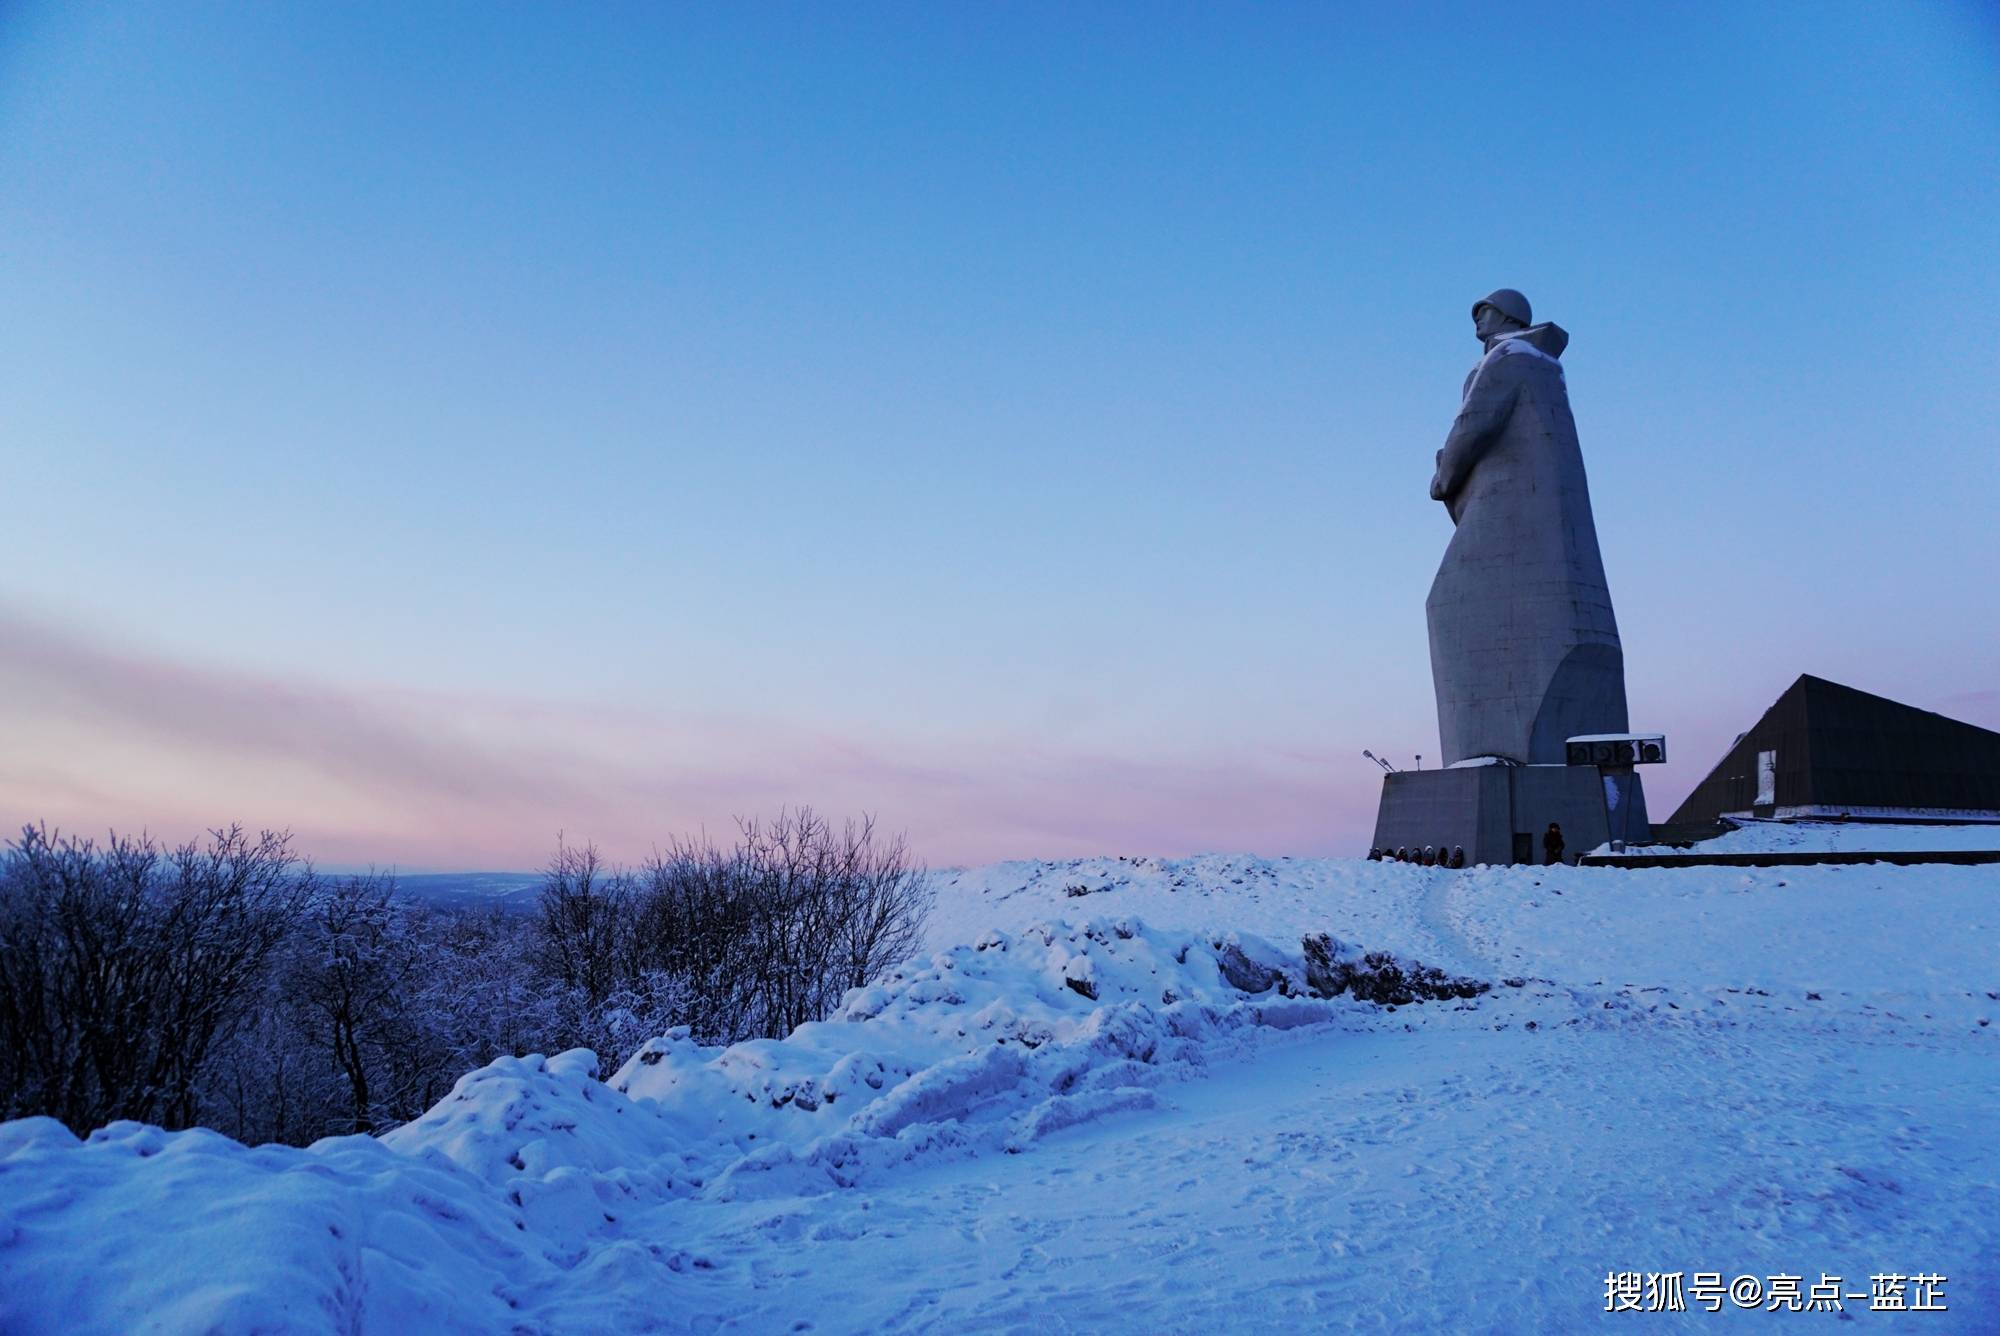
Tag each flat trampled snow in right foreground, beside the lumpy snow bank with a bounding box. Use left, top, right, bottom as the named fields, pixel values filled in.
left=632, top=1008, right=2000, bottom=1332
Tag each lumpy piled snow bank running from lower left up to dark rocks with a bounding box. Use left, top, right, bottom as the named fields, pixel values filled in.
left=0, top=918, right=1392, bottom=1332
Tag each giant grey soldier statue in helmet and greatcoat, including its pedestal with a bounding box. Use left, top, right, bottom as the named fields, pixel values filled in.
left=1376, top=288, right=1664, bottom=866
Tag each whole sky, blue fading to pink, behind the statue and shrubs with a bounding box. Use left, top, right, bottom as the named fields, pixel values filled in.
left=0, top=4, right=2000, bottom=868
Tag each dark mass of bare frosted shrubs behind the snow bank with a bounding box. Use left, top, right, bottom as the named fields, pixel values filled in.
left=0, top=808, right=930, bottom=1144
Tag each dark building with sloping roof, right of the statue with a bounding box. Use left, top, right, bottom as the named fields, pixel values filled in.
left=1668, top=674, right=2000, bottom=826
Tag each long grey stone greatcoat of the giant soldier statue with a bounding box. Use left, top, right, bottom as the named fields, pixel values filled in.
left=1424, top=324, right=1626, bottom=764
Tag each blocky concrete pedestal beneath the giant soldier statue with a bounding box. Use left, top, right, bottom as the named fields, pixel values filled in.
left=1374, top=766, right=1650, bottom=866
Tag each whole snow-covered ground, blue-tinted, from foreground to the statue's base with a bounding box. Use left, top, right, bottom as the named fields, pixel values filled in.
left=0, top=856, right=2000, bottom=1332
